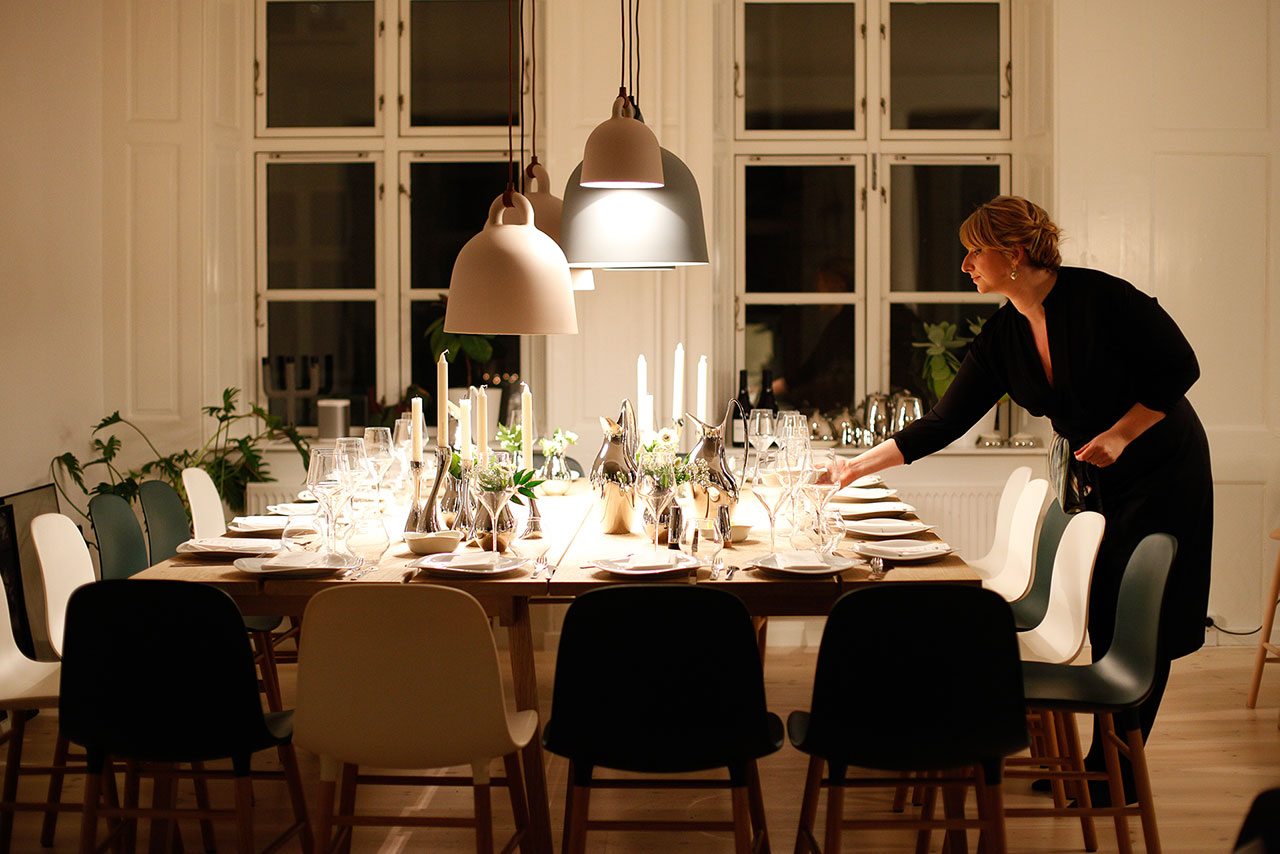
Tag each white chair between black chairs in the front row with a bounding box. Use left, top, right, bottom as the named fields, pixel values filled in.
left=293, top=584, right=538, bottom=854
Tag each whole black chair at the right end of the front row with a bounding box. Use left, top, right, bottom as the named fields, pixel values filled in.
left=787, top=584, right=1027, bottom=854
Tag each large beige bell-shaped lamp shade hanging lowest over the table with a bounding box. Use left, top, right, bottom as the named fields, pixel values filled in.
left=444, top=192, right=577, bottom=335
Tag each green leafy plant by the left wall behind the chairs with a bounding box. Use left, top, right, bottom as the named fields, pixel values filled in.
left=49, top=388, right=311, bottom=519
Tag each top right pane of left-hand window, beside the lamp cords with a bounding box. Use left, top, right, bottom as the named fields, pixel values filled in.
left=410, top=0, right=520, bottom=127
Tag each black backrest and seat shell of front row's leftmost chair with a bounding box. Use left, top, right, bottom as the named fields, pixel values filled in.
left=59, top=579, right=271, bottom=762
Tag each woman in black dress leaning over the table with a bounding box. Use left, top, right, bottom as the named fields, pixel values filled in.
left=844, top=196, right=1213, bottom=803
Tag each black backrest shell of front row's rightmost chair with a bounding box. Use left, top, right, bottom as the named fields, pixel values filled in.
left=805, top=584, right=1027, bottom=771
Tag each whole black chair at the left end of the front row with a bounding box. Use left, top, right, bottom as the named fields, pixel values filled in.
left=59, top=579, right=311, bottom=854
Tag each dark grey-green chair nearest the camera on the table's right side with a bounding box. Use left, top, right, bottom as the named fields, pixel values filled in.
left=1005, top=534, right=1178, bottom=854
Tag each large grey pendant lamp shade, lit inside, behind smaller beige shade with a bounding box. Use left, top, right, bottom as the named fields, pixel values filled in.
left=561, top=149, right=707, bottom=270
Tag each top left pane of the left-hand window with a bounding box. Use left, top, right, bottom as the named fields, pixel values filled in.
left=266, top=0, right=376, bottom=128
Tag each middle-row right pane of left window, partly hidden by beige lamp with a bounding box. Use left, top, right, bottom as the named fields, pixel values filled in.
left=410, top=163, right=507, bottom=288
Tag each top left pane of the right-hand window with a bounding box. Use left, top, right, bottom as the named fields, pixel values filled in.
left=742, top=3, right=859, bottom=131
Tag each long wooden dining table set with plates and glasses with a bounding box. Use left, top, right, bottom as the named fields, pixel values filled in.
left=133, top=480, right=980, bottom=854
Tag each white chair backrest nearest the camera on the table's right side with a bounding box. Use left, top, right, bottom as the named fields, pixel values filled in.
left=1018, top=510, right=1106, bottom=663
